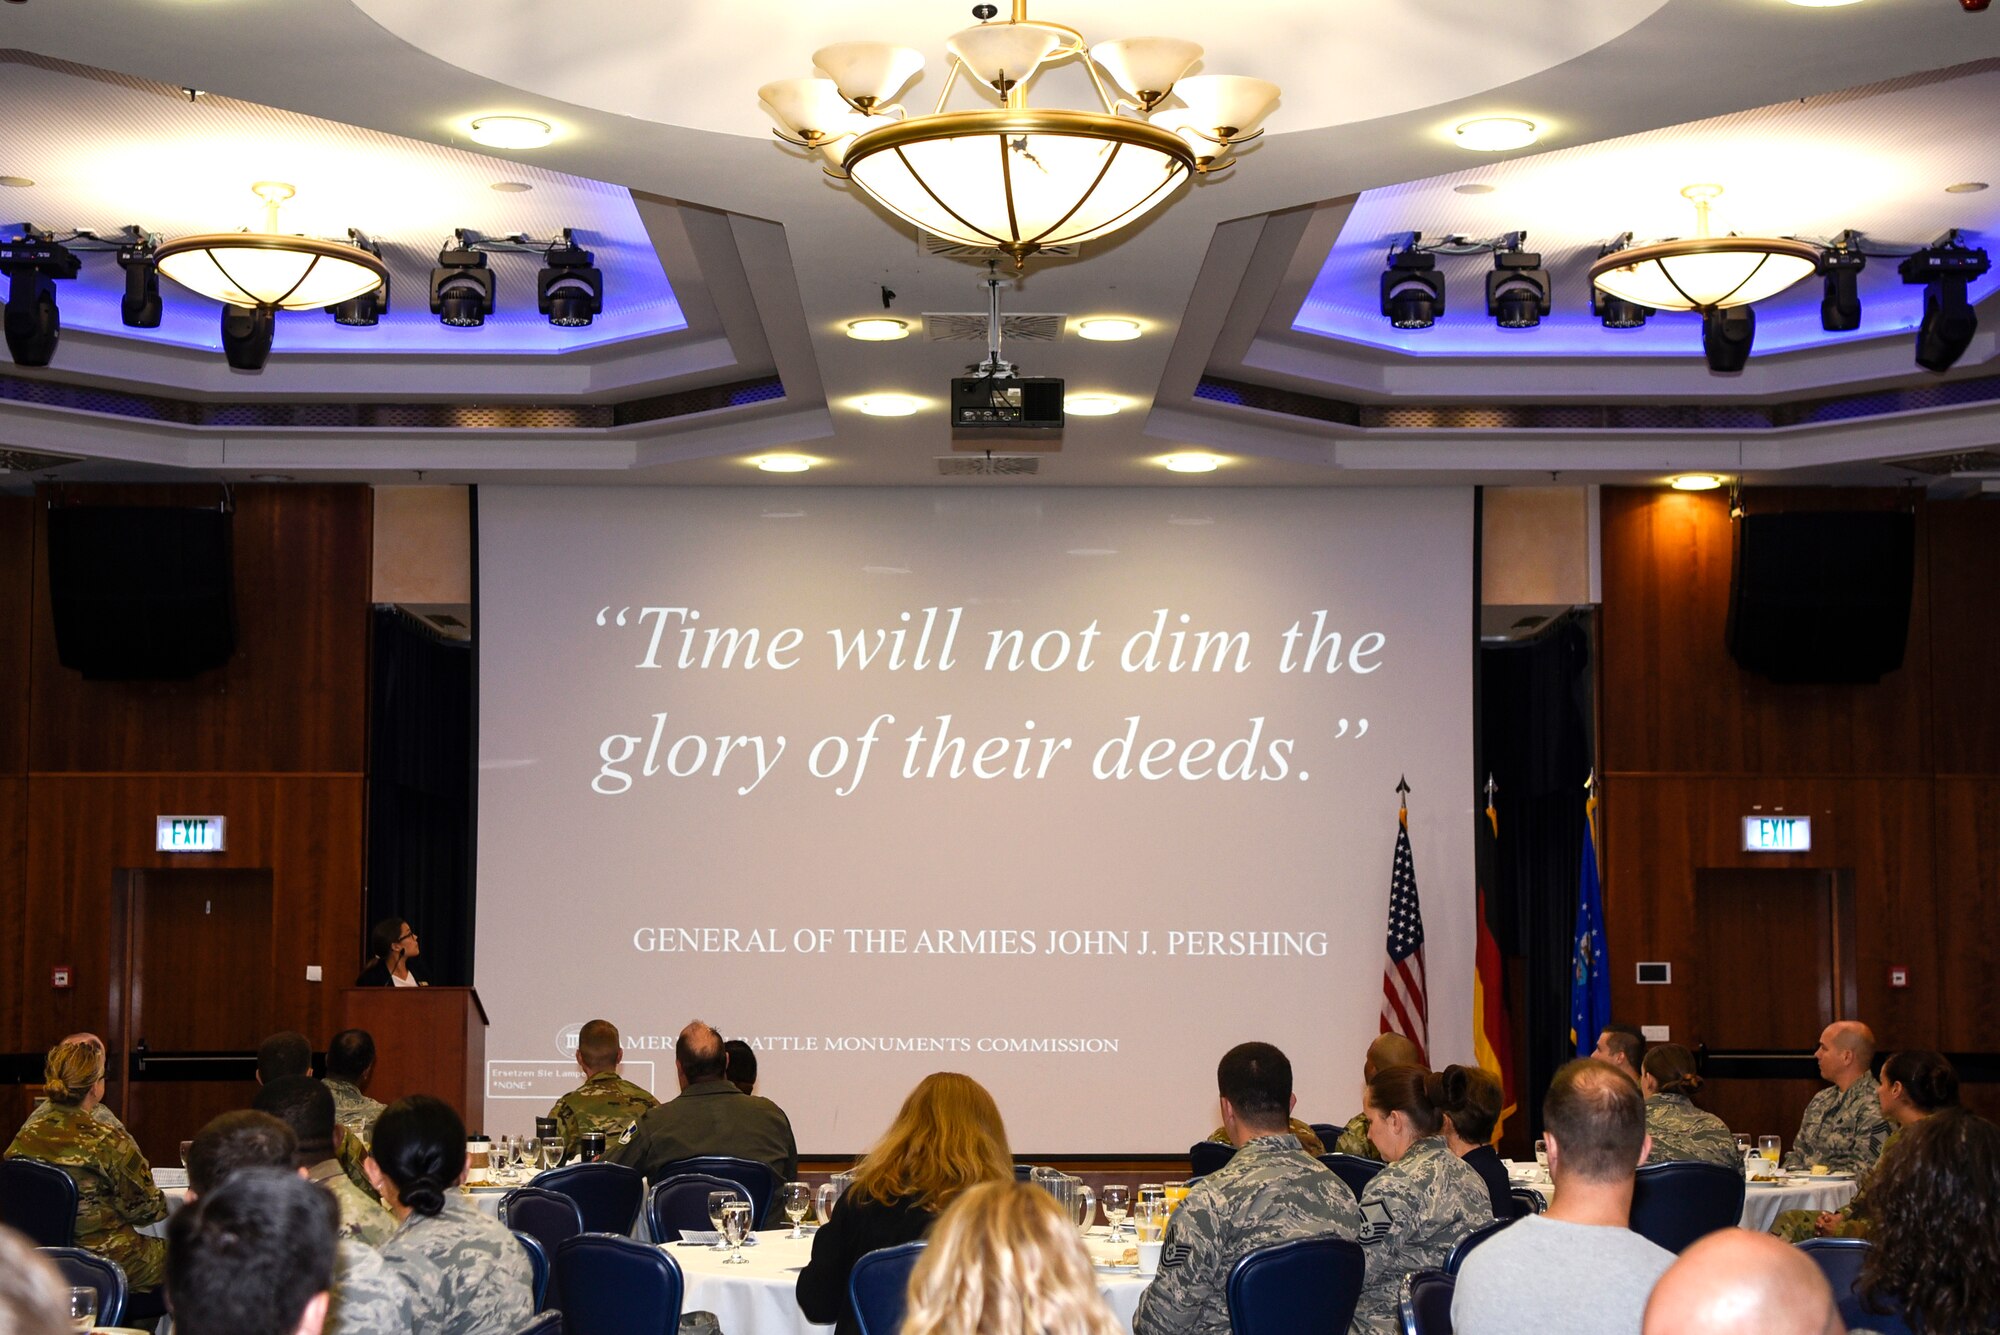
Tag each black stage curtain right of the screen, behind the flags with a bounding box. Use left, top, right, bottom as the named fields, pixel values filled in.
left=1480, top=612, right=1596, bottom=1131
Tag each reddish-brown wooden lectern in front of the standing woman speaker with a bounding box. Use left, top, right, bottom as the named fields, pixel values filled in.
left=340, top=987, right=486, bottom=1131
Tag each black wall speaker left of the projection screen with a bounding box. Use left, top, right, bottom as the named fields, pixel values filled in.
left=48, top=506, right=236, bottom=681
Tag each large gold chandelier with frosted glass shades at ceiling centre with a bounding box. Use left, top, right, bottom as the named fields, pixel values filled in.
left=758, top=0, right=1278, bottom=268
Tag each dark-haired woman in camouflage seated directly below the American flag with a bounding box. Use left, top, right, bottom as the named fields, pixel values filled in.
left=1354, top=1065, right=1496, bottom=1335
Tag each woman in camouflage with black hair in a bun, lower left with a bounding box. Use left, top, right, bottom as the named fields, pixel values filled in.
left=368, top=1093, right=534, bottom=1335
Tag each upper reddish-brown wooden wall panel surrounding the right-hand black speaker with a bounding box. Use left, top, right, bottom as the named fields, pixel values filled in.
left=1600, top=488, right=1932, bottom=775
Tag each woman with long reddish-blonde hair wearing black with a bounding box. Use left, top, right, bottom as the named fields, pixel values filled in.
left=798, top=1071, right=1016, bottom=1335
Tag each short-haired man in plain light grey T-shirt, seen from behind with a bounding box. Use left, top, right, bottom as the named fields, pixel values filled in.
left=1452, top=1049, right=1692, bottom=1335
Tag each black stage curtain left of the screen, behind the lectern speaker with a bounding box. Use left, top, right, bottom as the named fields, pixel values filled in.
left=368, top=608, right=472, bottom=987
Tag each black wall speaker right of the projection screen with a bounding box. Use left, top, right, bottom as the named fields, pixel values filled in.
left=1728, top=510, right=1916, bottom=681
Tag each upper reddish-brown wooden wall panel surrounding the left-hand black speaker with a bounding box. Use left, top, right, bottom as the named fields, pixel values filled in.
left=28, top=486, right=372, bottom=773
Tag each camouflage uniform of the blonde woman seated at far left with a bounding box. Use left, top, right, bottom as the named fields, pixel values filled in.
left=6, top=1103, right=166, bottom=1289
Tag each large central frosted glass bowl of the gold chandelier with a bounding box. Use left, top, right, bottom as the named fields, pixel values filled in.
left=846, top=110, right=1194, bottom=260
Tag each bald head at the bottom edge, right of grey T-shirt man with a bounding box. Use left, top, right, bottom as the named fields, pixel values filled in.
left=1644, top=1229, right=1848, bottom=1335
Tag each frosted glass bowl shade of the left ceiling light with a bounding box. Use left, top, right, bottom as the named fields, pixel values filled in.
left=158, top=232, right=388, bottom=310
